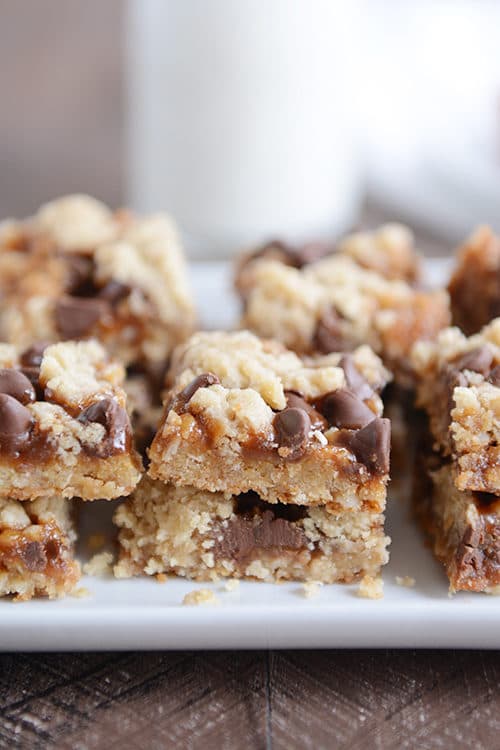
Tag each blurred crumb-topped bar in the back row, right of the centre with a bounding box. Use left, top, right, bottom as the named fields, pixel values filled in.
left=237, top=226, right=450, bottom=386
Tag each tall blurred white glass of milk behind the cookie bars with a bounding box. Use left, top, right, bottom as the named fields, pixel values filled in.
left=127, top=0, right=360, bottom=257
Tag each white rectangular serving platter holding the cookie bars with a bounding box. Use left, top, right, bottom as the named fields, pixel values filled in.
left=0, top=261, right=500, bottom=651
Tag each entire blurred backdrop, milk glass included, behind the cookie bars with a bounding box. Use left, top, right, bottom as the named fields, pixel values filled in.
left=0, top=0, right=500, bottom=257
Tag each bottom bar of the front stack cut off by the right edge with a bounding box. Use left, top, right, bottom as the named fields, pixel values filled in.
left=414, top=454, right=500, bottom=593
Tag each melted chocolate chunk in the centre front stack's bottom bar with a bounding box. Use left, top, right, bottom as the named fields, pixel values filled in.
left=215, top=510, right=307, bottom=561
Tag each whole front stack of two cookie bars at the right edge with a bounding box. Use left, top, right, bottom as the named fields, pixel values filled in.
left=413, top=318, right=500, bottom=591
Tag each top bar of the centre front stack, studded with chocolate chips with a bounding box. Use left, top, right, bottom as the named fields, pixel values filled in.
left=149, top=331, right=390, bottom=512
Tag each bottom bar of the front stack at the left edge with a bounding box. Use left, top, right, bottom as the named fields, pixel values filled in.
left=0, top=497, right=80, bottom=600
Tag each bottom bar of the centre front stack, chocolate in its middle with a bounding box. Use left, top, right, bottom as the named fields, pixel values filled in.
left=115, top=478, right=390, bottom=583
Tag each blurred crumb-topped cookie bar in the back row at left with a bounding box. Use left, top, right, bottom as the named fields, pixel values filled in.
left=0, top=195, right=194, bottom=370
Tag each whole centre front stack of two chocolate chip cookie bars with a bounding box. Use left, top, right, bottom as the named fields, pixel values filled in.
left=115, top=331, right=390, bottom=582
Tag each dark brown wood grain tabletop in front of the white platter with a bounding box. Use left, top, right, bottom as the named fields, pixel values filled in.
left=0, top=651, right=500, bottom=750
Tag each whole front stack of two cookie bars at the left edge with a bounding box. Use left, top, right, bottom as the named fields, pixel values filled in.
left=0, top=341, right=142, bottom=599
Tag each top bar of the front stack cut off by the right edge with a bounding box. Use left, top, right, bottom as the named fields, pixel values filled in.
left=413, top=318, right=500, bottom=494
